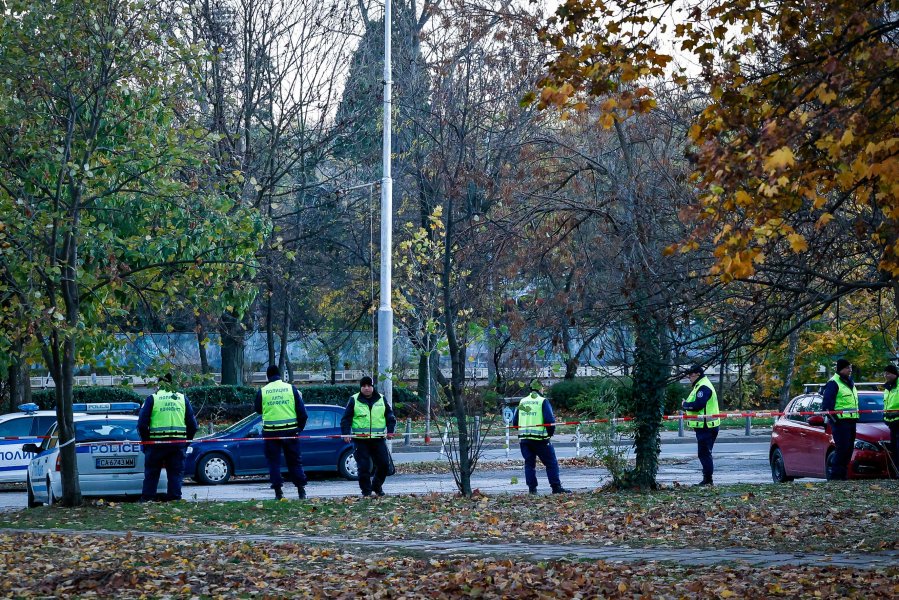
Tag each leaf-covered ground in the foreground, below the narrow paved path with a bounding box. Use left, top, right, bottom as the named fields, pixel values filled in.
left=0, top=534, right=899, bottom=598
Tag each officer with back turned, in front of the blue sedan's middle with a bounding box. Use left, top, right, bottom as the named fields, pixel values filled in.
left=254, top=365, right=309, bottom=500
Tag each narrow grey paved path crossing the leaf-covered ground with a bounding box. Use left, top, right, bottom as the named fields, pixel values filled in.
left=10, top=529, right=899, bottom=569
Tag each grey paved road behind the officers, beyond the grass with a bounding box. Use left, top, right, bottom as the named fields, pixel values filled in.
left=0, top=440, right=771, bottom=510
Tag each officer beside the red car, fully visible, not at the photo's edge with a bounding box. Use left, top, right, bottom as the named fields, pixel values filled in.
left=821, top=358, right=858, bottom=481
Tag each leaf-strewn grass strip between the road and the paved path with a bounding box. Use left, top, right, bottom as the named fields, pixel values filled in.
left=7, top=481, right=899, bottom=552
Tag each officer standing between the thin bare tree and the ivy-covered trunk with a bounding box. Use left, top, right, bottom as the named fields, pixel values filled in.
left=512, top=380, right=569, bottom=494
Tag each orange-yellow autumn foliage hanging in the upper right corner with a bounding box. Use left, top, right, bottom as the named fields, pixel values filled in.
left=529, top=0, right=899, bottom=281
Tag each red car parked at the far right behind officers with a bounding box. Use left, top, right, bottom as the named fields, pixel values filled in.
left=768, top=390, right=890, bottom=483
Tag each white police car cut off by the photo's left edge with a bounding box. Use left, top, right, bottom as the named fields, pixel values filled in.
left=0, top=404, right=87, bottom=483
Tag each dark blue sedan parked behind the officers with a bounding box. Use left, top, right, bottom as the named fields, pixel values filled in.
left=184, top=404, right=359, bottom=485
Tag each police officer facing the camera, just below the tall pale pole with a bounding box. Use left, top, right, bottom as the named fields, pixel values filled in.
left=340, top=375, right=396, bottom=497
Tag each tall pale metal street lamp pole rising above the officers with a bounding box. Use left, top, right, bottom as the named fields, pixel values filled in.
left=378, top=0, right=393, bottom=406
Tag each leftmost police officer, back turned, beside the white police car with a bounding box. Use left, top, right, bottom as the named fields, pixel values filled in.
left=137, top=373, right=197, bottom=502
